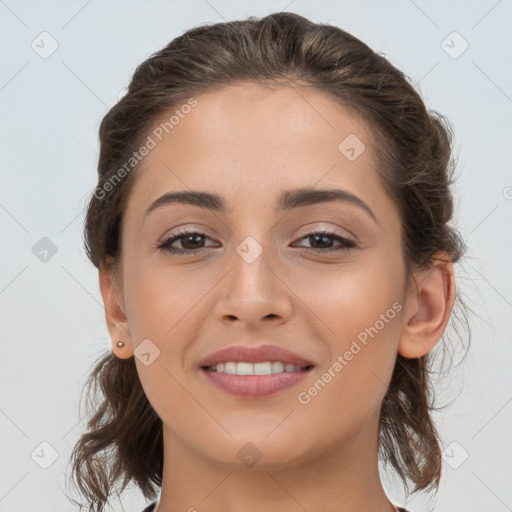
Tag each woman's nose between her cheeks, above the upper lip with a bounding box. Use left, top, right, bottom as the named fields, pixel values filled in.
left=215, top=243, right=293, bottom=328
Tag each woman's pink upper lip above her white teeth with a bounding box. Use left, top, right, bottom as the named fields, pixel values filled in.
left=199, top=345, right=313, bottom=367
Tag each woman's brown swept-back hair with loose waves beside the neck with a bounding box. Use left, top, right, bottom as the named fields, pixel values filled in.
left=67, top=12, right=467, bottom=511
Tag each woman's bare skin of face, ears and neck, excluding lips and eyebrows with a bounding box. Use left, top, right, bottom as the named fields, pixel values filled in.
left=100, top=83, right=455, bottom=512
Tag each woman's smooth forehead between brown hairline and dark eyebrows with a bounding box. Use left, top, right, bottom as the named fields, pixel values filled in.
left=128, top=83, right=383, bottom=220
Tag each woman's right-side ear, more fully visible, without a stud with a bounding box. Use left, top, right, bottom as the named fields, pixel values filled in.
left=398, top=252, right=455, bottom=358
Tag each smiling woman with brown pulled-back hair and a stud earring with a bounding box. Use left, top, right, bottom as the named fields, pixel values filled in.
left=66, top=13, right=470, bottom=512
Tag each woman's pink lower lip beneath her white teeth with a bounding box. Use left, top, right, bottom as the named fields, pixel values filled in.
left=201, top=368, right=312, bottom=397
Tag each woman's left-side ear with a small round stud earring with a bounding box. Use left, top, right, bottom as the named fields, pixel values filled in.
left=99, top=263, right=133, bottom=359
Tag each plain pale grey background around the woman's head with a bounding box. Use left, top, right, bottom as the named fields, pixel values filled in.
left=0, top=0, right=512, bottom=512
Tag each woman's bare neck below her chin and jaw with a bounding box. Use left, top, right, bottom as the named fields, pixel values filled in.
left=155, top=408, right=397, bottom=512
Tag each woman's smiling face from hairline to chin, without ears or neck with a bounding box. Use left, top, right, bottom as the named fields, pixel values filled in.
left=107, top=84, right=412, bottom=468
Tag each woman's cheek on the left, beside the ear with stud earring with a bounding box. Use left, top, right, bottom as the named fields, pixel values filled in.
left=127, top=266, right=207, bottom=424
